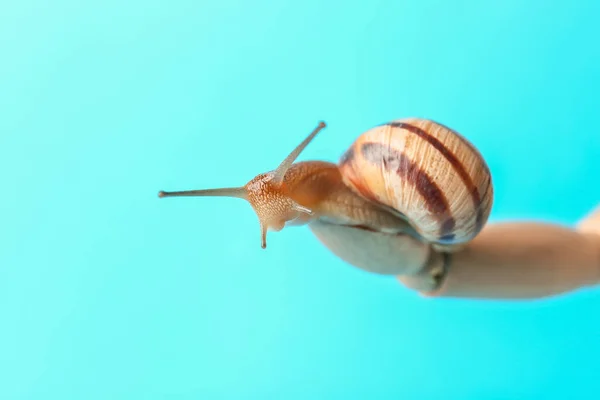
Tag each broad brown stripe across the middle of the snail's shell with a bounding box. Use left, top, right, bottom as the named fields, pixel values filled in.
left=360, top=143, right=456, bottom=241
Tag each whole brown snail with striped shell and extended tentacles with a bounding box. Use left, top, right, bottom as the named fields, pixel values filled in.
left=159, top=118, right=493, bottom=264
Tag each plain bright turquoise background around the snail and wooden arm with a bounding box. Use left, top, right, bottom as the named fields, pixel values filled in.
left=0, top=0, right=600, bottom=400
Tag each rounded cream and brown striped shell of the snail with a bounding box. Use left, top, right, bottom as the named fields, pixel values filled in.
left=339, top=118, right=493, bottom=245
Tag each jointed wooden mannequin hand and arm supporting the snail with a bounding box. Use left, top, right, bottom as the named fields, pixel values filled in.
left=310, top=207, right=600, bottom=299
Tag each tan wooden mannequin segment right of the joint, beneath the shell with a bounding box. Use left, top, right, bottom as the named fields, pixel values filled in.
left=398, top=211, right=600, bottom=299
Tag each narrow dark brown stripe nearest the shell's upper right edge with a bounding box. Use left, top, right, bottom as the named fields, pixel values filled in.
left=385, top=121, right=485, bottom=240
